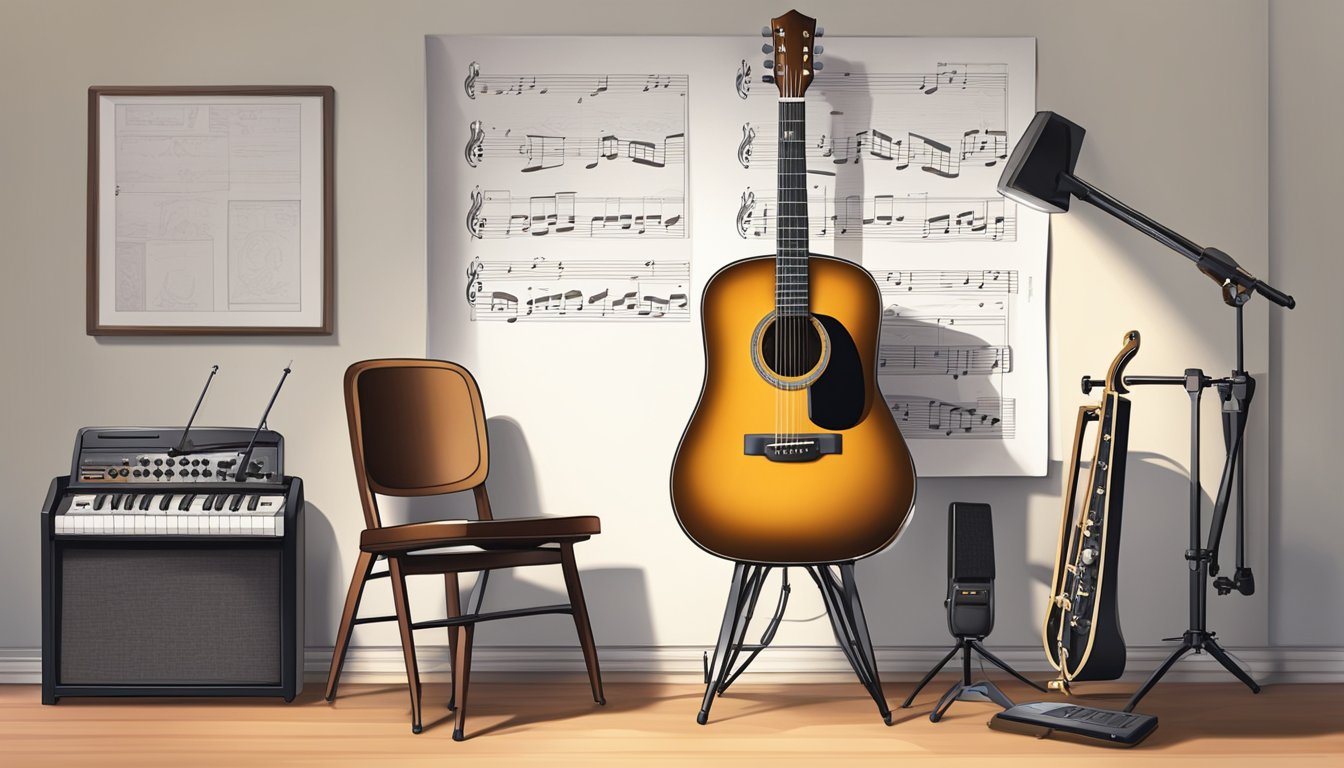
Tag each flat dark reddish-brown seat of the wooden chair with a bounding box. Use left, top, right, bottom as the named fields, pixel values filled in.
left=359, top=515, right=602, bottom=554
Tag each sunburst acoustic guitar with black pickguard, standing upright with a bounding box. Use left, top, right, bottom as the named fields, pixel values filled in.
left=672, top=11, right=915, bottom=565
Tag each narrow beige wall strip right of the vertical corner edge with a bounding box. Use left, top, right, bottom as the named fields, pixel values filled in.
left=1269, top=0, right=1344, bottom=647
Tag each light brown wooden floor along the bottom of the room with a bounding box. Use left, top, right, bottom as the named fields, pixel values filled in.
left=0, top=677, right=1344, bottom=768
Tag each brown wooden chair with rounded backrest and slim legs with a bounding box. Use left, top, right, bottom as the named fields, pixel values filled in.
left=327, top=359, right=606, bottom=741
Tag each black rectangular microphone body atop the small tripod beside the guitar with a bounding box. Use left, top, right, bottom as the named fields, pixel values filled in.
left=946, top=502, right=995, bottom=638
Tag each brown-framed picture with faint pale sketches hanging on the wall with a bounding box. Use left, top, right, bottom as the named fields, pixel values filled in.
left=87, top=86, right=335, bottom=335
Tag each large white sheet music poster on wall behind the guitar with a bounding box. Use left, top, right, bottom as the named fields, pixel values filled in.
left=426, top=36, right=1048, bottom=487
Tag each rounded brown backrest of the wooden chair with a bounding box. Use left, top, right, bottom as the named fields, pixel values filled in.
left=345, top=359, right=489, bottom=527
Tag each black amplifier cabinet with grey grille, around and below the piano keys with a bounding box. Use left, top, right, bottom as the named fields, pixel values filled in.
left=42, top=477, right=304, bottom=703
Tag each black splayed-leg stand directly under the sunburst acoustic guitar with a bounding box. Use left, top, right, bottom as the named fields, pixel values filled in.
left=695, top=562, right=891, bottom=725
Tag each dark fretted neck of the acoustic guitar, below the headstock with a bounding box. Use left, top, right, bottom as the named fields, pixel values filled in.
left=774, top=98, right=810, bottom=316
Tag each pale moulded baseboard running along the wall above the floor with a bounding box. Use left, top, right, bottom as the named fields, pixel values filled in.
left=0, top=643, right=1344, bottom=685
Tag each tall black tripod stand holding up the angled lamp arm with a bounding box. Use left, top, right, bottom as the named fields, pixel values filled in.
left=1118, top=302, right=1261, bottom=712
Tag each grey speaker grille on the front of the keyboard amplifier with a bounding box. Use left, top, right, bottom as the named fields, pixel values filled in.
left=58, top=546, right=281, bottom=685
